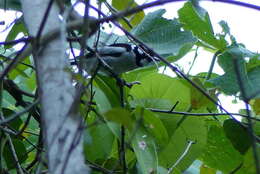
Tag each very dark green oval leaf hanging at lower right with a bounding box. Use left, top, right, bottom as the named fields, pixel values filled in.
left=223, top=119, right=251, bottom=154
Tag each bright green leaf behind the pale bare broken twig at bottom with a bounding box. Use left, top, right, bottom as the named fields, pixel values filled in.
left=159, top=117, right=207, bottom=171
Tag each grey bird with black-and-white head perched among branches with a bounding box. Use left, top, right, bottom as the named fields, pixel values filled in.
left=72, top=43, right=159, bottom=75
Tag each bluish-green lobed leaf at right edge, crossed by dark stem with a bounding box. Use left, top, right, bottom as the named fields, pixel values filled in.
left=210, top=45, right=260, bottom=97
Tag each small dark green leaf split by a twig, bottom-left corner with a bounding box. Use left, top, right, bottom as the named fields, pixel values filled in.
left=3, top=139, right=28, bottom=170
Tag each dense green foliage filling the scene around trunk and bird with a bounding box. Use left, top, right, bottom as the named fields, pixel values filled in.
left=0, top=0, right=260, bottom=174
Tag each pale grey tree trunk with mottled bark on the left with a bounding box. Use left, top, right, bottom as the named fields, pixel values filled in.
left=21, top=0, right=88, bottom=174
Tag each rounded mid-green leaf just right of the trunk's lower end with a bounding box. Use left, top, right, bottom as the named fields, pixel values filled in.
left=84, top=124, right=114, bottom=161
